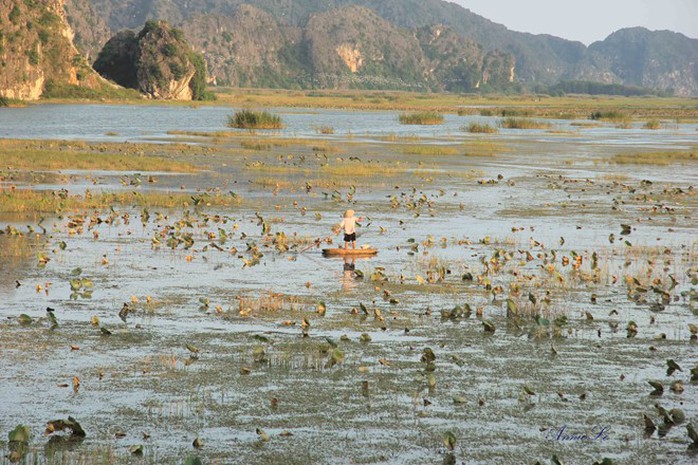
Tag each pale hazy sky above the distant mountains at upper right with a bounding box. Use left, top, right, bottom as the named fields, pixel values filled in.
left=449, top=0, right=698, bottom=45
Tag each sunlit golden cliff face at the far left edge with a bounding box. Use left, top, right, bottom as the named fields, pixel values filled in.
left=0, top=0, right=101, bottom=100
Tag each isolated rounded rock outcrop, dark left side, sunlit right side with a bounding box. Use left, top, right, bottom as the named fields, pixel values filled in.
left=94, top=21, right=205, bottom=100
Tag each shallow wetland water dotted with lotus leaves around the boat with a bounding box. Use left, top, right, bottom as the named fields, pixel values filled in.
left=0, top=105, right=698, bottom=464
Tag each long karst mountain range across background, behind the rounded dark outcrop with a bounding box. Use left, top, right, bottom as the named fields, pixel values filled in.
left=0, top=0, right=698, bottom=98
